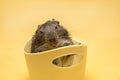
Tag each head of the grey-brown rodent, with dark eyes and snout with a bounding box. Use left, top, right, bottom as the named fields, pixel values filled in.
left=39, top=19, right=69, bottom=42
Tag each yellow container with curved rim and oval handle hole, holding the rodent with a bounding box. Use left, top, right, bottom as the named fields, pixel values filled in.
left=24, top=40, right=87, bottom=80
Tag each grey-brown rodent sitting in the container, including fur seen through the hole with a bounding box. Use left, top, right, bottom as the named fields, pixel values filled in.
left=31, top=19, right=74, bottom=67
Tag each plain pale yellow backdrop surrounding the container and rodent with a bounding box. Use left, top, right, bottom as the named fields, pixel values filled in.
left=0, top=0, right=120, bottom=80
